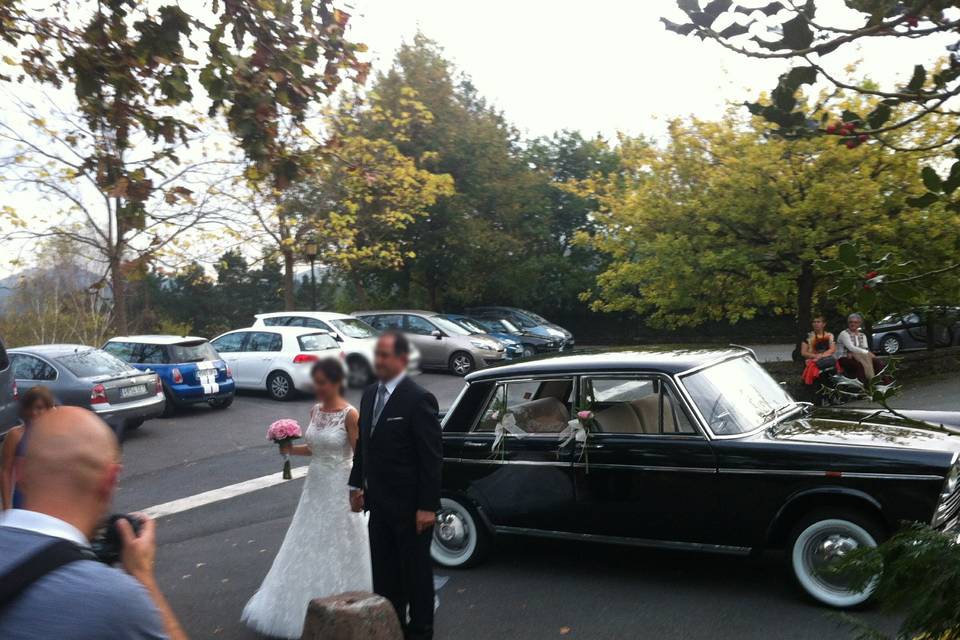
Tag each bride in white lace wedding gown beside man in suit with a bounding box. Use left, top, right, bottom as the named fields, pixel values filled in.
left=242, top=358, right=372, bottom=638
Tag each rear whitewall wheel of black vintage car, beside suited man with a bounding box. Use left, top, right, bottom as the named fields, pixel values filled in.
left=430, top=498, right=490, bottom=568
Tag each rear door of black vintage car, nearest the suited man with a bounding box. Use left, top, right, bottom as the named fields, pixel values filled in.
left=444, top=376, right=575, bottom=532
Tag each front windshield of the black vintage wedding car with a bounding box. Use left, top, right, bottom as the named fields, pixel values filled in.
left=683, top=356, right=796, bottom=435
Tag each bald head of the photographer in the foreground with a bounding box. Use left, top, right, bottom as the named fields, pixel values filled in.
left=20, top=407, right=120, bottom=537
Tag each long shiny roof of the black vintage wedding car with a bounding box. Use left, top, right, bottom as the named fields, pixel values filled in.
left=467, top=347, right=750, bottom=381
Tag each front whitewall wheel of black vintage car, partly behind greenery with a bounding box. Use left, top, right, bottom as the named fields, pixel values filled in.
left=787, top=509, right=882, bottom=609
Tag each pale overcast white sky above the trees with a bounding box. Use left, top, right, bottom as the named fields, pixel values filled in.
left=0, top=0, right=947, bottom=278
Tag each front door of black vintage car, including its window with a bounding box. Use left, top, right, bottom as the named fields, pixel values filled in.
left=571, top=374, right=717, bottom=543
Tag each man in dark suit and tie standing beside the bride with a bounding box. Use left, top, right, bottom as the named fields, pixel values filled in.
left=350, top=331, right=443, bottom=640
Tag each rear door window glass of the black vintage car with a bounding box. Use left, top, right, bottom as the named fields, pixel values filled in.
left=474, top=378, right=575, bottom=435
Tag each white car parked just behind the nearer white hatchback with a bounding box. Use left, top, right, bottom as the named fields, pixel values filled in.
left=253, top=311, right=420, bottom=387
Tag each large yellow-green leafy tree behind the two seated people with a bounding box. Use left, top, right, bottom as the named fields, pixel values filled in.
left=579, top=105, right=960, bottom=338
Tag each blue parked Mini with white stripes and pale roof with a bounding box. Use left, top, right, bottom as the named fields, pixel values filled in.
left=103, top=335, right=234, bottom=414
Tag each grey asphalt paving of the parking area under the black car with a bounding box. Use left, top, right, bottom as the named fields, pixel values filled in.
left=110, top=364, right=960, bottom=640
